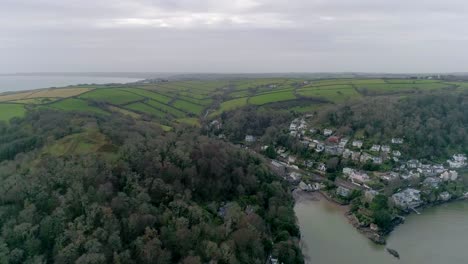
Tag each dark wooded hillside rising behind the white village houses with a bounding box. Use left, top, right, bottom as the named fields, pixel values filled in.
left=316, top=92, right=468, bottom=160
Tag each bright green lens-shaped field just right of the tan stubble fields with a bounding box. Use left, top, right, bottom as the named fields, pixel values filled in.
left=79, top=88, right=144, bottom=105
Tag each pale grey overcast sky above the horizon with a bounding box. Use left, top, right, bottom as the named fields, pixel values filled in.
left=0, top=0, right=468, bottom=73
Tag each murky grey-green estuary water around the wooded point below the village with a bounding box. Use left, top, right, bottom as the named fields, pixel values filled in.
left=295, top=192, right=468, bottom=264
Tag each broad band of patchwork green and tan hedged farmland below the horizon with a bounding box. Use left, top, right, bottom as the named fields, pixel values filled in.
left=0, top=78, right=468, bottom=124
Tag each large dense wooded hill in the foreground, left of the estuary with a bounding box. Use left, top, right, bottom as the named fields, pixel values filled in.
left=0, top=111, right=303, bottom=264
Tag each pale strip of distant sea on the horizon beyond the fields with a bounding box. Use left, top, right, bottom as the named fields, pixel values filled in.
left=0, top=75, right=142, bottom=93
